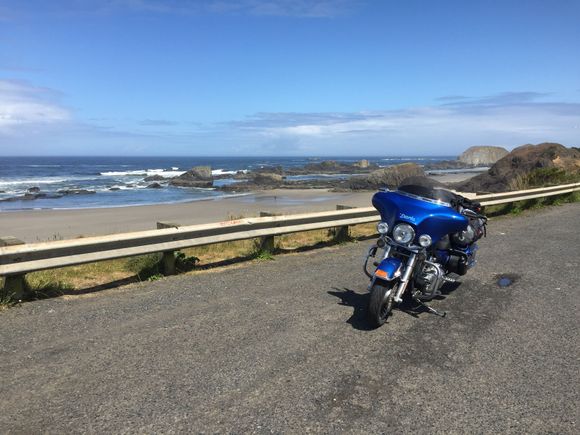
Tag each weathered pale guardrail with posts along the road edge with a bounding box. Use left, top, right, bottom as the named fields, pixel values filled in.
left=0, top=183, right=580, bottom=295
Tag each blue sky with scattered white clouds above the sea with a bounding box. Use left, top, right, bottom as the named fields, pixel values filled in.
left=0, top=0, right=580, bottom=156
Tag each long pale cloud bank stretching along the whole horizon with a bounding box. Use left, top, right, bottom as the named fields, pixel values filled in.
left=0, top=80, right=580, bottom=155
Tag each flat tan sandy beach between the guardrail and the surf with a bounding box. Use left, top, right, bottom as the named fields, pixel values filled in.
left=0, top=173, right=476, bottom=242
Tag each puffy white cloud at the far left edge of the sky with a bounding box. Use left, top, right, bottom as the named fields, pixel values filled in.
left=0, top=80, right=71, bottom=135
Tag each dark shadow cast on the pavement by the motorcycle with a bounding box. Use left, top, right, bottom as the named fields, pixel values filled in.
left=327, top=282, right=461, bottom=331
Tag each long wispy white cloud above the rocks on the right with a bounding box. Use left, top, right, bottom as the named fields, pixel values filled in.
left=232, top=92, right=580, bottom=153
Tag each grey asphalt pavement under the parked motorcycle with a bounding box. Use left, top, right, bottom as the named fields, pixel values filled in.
left=0, top=204, right=580, bottom=434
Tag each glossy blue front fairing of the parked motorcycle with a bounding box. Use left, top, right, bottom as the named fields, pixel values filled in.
left=373, top=191, right=468, bottom=243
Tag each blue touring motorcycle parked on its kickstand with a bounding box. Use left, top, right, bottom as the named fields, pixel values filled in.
left=364, top=185, right=487, bottom=328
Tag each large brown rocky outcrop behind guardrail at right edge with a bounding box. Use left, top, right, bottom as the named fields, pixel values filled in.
left=454, top=143, right=580, bottom=192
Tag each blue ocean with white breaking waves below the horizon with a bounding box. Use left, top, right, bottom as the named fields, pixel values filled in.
left=0, top=156, right=455, bottom=212
